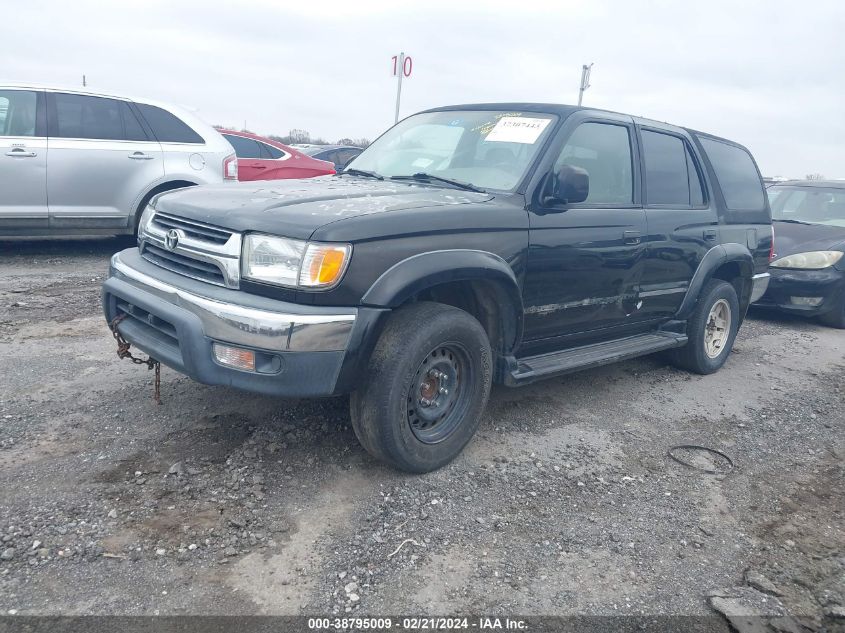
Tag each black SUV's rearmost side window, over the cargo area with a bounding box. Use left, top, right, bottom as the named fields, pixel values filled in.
left=698, top=136, right=766, bottom=211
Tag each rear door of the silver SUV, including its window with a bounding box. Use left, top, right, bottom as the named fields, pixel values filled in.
left=47, top=92, right=164, bottom=229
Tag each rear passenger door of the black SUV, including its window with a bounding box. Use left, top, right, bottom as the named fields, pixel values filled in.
left=638, top=122, right=720, bottom=317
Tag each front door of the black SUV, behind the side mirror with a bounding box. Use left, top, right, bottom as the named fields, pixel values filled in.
left=522, top=115, right=647, bottom=353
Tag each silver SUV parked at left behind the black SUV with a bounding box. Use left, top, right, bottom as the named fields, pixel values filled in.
left=0, top=85, right=238, bottom=236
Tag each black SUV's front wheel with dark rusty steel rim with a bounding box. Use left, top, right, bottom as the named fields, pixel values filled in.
left=350, top=302, right=492, bottom=473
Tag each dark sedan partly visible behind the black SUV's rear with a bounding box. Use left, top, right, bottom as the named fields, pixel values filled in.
left=756, top=180, right=845, bottom=328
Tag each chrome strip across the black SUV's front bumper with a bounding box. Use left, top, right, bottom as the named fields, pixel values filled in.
left=111, top=253, right=357, bottom=352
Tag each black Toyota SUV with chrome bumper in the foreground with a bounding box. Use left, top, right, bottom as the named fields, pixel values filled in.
left=103, top=103, right=772, bottom=472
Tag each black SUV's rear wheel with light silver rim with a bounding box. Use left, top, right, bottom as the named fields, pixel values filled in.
left=670, top=279, right=741, bottom=374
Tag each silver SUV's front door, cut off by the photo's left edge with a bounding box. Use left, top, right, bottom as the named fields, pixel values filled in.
left=0, top=89, right=48, bottom=231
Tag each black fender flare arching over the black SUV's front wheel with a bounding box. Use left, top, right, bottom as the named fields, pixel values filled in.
left=361, top=249, right=524, bottom=353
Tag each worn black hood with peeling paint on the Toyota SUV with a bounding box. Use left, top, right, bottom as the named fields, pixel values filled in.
left=154, top=176, right=492, bottom=239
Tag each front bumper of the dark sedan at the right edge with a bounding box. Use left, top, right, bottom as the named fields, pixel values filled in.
left=754, top=267, right=845, bottom=316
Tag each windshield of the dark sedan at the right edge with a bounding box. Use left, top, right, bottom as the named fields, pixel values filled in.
left=767, top=186, right=845, bottom=227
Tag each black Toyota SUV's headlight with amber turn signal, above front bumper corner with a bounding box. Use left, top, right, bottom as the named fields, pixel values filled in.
left=243, top=233, right=352, bottom=288
